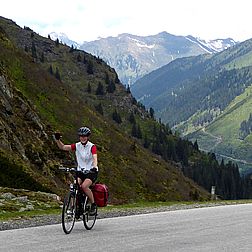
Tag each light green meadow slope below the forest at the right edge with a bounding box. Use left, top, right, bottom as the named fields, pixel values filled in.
left=187, top=86, right=252, bottom=173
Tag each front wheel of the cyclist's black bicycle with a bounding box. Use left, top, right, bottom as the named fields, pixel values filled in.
left=62, top=192, right=76, bottom=234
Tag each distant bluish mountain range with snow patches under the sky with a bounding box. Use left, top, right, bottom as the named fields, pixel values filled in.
left=50, top=32, right=237, bottom=86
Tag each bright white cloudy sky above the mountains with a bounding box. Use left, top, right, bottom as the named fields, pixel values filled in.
left=0, top=0, right=252, bottom=43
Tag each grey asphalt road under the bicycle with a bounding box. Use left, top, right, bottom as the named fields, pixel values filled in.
left=0, top=204, right=252, bottom=252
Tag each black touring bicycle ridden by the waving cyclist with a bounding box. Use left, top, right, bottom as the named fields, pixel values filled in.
left=59, top=167, right=97, bottom=234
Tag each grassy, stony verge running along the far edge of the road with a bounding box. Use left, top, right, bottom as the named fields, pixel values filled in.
left=0, top=187, right=252, bottom=222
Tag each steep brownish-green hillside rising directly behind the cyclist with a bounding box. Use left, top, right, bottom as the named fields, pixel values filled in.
left=0, top=18, right=212, bottom=203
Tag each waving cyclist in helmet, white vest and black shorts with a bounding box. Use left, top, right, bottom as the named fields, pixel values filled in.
left=53, top=127, right=98, bottom=215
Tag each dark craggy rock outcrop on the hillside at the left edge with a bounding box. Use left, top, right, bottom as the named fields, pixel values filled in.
left=0, top=67, right=48, bottom=163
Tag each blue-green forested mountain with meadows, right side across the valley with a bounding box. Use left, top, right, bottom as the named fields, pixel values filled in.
left=131, top=40, right=252, bottom=173
